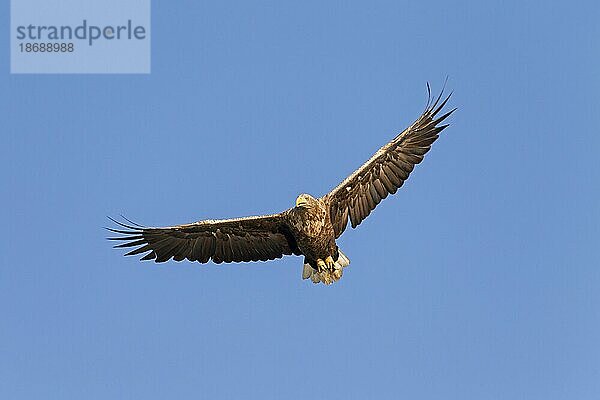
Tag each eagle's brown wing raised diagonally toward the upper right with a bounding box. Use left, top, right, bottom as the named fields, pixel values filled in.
left=325, top=85, right=456, bottom=238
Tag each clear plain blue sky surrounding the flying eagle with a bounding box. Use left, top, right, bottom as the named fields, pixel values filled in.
left=0, top=1, right=600, bottom=400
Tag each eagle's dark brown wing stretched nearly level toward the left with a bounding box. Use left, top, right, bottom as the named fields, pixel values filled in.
left=107, top=214, right=299, bottom=264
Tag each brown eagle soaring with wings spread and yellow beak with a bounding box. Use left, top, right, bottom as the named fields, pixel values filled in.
left=106, top=84, right=456, bottom=285
